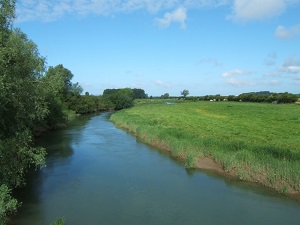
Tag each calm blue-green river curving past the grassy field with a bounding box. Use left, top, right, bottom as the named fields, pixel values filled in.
left=11, top=113, right=300, bottom=225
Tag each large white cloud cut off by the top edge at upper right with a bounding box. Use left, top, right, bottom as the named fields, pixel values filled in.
left=228, top=0, right=289, bottom=21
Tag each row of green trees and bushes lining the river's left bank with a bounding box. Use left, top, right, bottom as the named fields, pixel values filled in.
left=0, top=0, right=147, bottom=224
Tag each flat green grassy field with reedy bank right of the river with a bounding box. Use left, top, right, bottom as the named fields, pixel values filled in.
left=111, top=102, right=300, bottom=196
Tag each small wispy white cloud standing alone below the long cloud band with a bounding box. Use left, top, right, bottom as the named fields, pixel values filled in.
left=155, top=7, right=187, bottom=29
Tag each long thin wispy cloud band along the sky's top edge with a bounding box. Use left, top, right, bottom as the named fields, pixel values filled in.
left=16, top=0, right=231, bottom=22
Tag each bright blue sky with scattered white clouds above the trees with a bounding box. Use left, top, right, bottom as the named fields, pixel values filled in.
left=15, top=0, right=300, bottom=96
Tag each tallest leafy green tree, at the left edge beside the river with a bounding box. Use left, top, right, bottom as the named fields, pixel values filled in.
left=0, top=0, right=48, bottom=221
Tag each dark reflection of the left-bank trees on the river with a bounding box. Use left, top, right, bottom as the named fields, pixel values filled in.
left=14, top=115, right=94, bottom=212
